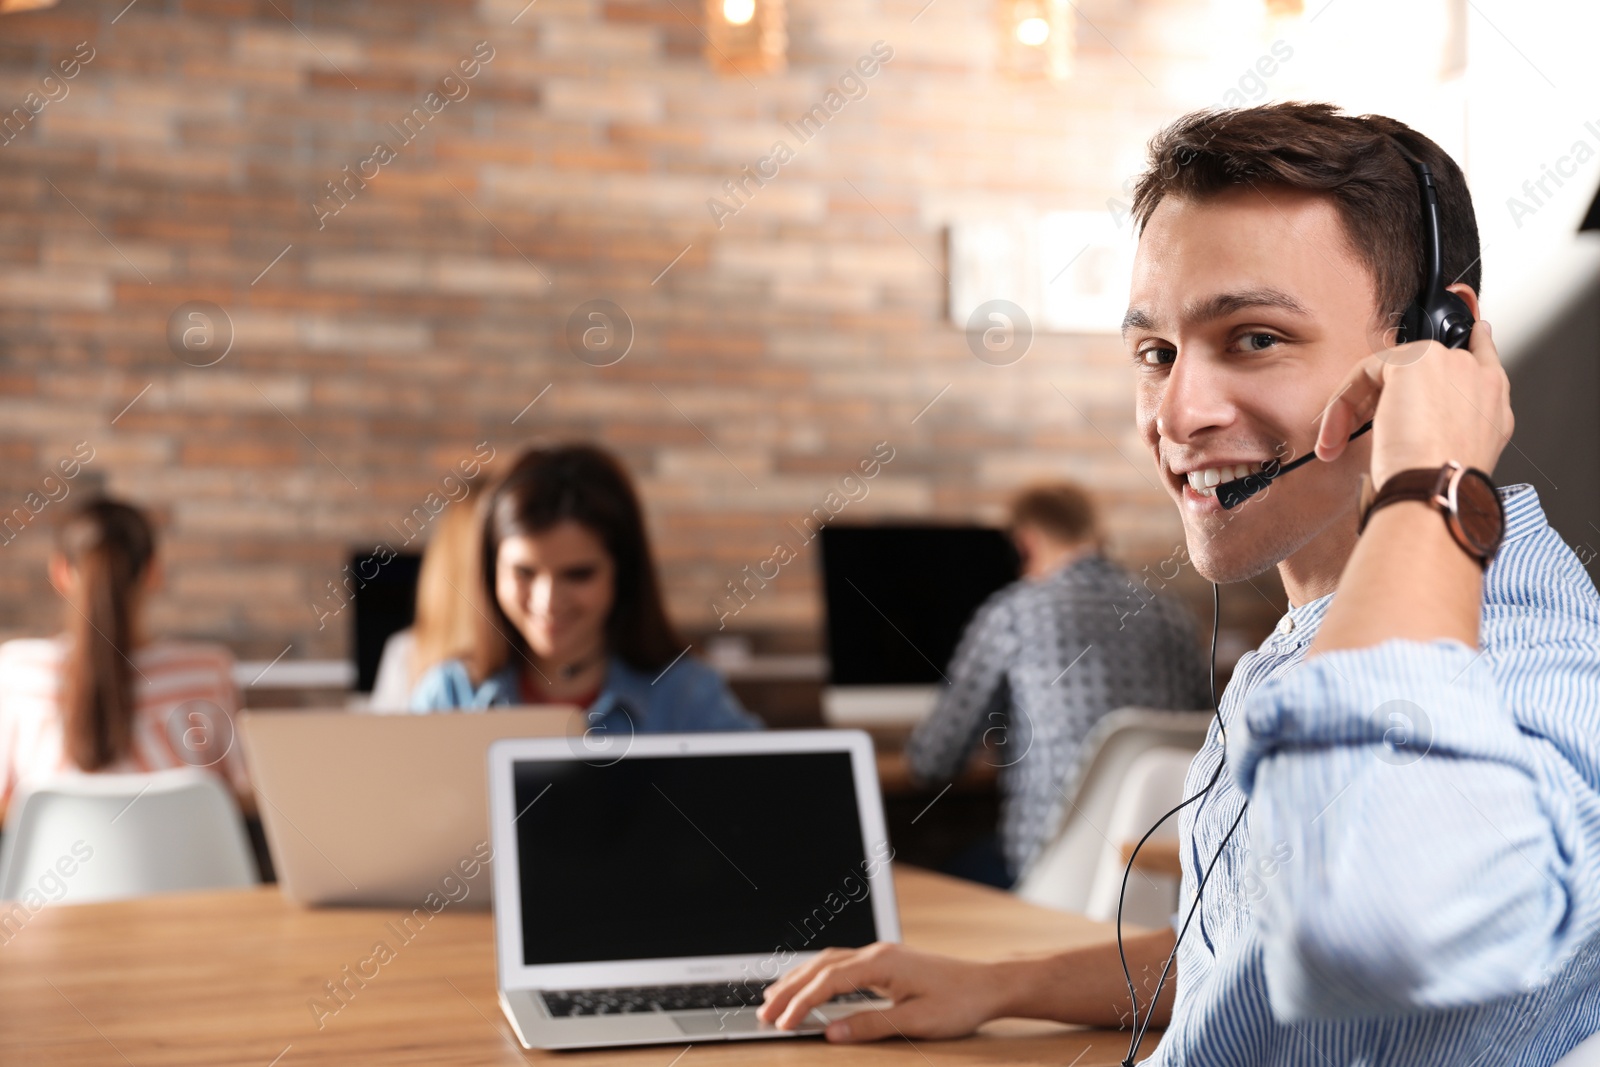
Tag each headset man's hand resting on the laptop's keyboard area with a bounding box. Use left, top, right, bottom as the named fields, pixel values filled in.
left=760, top=941, right=1000, bottom=1041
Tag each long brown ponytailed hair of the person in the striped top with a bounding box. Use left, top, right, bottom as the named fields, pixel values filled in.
left=56, top=499, right=155, bottom=771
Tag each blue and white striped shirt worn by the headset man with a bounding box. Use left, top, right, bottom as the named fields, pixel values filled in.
left=1149, top=485, right=1600, bottom=1067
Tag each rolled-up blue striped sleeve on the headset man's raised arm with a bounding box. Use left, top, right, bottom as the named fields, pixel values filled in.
left=1227, top=639, right=1600, bottom=1021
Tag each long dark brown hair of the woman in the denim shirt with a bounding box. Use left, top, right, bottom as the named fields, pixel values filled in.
left=470, top=445, right=683, bottom=683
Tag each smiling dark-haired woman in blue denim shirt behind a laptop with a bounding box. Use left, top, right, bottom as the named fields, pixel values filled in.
left=411, top=445, right=760, bottom=734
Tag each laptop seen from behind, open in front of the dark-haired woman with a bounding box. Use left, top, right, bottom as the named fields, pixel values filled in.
left=240, top=707, right=579, bottom=912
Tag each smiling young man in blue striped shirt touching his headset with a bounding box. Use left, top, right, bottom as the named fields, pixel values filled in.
left=763, top=97, right=1600, bottom=1067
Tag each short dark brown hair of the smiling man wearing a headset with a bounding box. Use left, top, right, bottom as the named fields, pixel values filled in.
left=1133, top=101, right=1483, bottom=334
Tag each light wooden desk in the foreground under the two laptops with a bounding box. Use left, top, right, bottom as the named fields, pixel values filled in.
left=0, top=867, right=1157, bottom=1067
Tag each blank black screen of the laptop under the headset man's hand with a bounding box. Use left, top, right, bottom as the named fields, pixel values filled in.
left=512, top=752, right=877, bottom=966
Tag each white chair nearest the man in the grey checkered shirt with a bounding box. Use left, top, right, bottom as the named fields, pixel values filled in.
left=1014, top=707, right=1211, bottom=925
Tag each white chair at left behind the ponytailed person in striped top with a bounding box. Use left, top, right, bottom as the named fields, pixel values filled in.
left=0, top=768, right=258, bottom=904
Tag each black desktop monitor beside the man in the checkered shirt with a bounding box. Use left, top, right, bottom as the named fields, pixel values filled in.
left=822, top=525, right=1019, bottom=685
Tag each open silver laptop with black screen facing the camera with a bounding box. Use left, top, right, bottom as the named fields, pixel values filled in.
left=490, top=729, right=899, bottom=1048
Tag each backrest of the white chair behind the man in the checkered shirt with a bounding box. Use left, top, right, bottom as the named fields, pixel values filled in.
left=1014, top=707, right=1211, bottom=921
